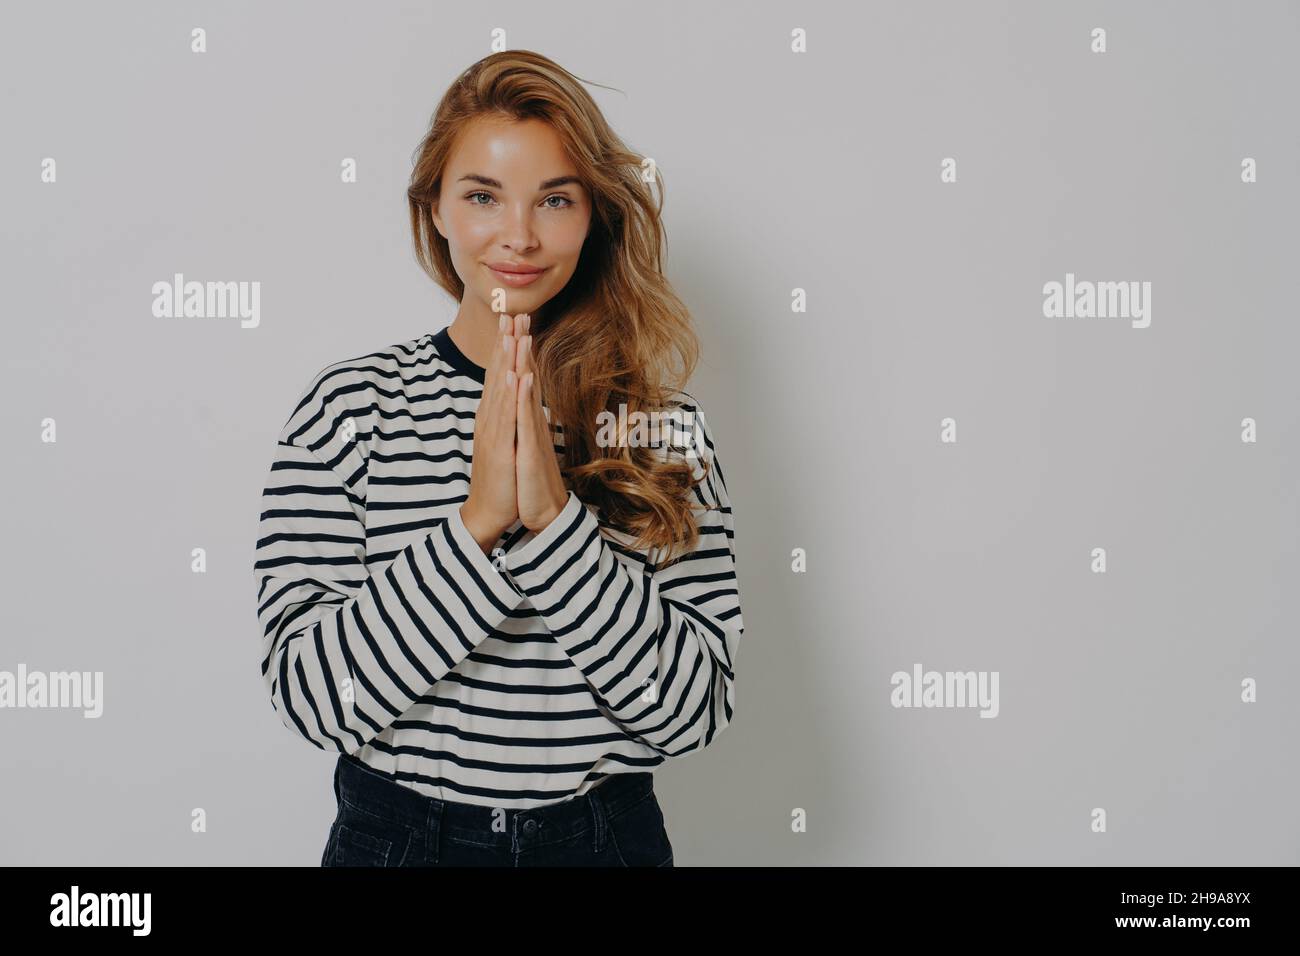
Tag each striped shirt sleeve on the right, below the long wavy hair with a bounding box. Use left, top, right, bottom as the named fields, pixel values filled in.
left=506, top=403, right=745, bottom=757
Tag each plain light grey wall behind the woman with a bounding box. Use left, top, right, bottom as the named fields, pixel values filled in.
left=0, top=3, right=1300, bottom=865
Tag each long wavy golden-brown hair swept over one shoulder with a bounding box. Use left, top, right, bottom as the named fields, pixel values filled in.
left=407, top=49, right=707, bottom=559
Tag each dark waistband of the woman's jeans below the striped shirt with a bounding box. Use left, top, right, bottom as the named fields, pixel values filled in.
left=334, top=753, right=654, bottom=847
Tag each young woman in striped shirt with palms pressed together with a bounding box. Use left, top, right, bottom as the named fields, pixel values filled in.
left=255, top=51, right=745, bottom=866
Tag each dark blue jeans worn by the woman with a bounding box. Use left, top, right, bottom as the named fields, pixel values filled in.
left=321, top=753, right=673, bottom=866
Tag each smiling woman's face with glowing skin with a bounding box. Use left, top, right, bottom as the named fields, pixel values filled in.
left=433, top=117, right=592, bottom=321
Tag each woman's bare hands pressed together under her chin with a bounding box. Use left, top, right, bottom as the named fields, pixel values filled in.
left=460, top=313, right=568, bottom=554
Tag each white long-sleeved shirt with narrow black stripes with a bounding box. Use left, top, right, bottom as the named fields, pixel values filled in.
left=254, top=329, right=745, bottom=809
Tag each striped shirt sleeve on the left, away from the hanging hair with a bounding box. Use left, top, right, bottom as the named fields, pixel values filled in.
left=254, top=369, right=523, bottom=753
